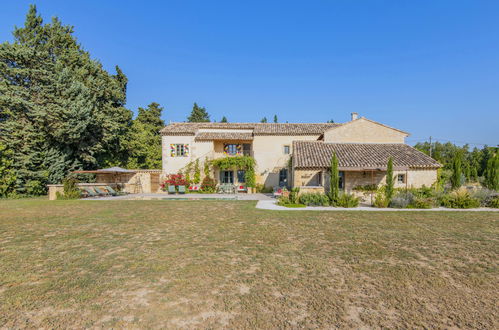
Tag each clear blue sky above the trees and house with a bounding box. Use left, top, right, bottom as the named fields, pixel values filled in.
left=0, top=0, right=499, bottom=145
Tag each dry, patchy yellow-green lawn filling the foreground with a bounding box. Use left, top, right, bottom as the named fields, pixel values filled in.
left=0, top=200, right=499, bottom=329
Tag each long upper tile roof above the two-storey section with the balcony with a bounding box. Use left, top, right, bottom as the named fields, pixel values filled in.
left=161, top=123, right=341, bottom=135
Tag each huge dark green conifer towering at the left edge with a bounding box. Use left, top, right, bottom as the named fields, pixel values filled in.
left=0, top=6, right=131, bottom=194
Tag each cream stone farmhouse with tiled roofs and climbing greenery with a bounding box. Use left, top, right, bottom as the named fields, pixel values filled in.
left=161, top=113, right=441, bottom=192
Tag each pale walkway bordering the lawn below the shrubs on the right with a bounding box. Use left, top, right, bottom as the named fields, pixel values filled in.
left=256, top=199, right=499, bottom=212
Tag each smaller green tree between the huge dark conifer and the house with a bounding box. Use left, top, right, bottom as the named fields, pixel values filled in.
left=127, top=102, right=165, bottom=169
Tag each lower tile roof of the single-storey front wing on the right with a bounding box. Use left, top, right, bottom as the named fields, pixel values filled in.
left=293, top=141, right=441, bottom=169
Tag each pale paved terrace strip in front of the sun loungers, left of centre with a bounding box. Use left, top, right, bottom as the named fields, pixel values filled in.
left=83, top=193, right=273, bottom=201
